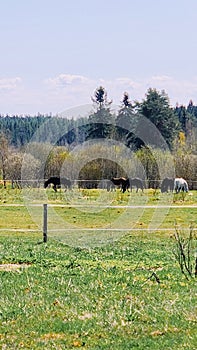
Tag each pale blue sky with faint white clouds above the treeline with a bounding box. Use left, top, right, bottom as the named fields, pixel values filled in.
left=0, top=0, right=197, bottom=115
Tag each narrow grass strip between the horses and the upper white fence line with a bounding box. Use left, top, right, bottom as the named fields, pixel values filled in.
left=0, top=186, right=197, bottom=206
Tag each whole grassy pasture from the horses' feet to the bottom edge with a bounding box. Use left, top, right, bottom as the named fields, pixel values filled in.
left=0, top=188, right=197, bottom=350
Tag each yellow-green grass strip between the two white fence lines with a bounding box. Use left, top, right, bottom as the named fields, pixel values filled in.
left=0, top=202, right=197, bottom=235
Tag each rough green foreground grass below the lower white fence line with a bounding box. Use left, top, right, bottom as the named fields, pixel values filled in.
left=0, top=233, right=197, bottom=350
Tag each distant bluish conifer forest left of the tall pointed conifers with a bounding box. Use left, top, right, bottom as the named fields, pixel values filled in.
left=0, top=115, right=89, bottom=149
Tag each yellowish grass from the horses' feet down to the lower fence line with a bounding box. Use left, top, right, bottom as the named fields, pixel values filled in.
left=0, top=189, right=197, bottom=230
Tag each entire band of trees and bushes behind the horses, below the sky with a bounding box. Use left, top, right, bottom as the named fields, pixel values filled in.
left=0, top=86, right=197, bottom=185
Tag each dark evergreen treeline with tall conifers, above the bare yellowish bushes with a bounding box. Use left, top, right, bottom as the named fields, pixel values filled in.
left=0, top=86, right=197, bottom=153
